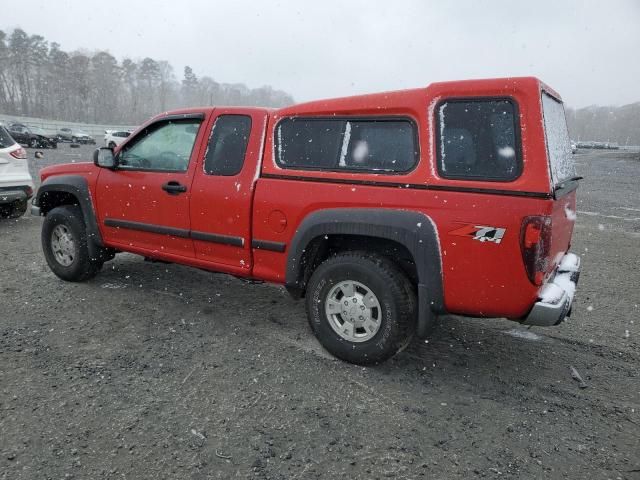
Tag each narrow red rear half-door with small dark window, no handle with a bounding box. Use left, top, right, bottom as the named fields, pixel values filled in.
left=191, top=108, right=267, bottom=275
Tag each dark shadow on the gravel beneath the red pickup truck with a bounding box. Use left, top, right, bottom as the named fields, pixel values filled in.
left=91, top=255, right=575, bottom=390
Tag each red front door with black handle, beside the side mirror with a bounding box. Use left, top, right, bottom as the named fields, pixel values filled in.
left=96, top=113, right=206, bottom=257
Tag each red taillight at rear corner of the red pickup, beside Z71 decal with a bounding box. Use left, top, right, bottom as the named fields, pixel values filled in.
left=520, top=216, right=551, bottom=285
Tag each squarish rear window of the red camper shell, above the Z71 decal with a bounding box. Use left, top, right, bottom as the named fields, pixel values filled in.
left=436, top=99, right=522, bottom=181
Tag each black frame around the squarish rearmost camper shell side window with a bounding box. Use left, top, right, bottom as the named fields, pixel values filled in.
left=433, top=95, right=524, bottom=183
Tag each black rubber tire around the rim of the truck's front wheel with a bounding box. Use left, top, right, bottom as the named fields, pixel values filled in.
left=41, top=205, right=103, bottom=282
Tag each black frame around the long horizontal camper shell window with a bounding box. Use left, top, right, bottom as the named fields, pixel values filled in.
left=273, top=115, right=420, bottom=175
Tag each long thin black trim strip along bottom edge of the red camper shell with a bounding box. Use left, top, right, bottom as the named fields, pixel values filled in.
left=260, top=173, right=553, bottom=199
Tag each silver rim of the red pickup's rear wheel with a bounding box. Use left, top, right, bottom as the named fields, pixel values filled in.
left=324, top=280, right=382, bottom=343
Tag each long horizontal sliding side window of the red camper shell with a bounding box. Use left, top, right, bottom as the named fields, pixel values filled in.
left=276, top=117, right=418, bottom=173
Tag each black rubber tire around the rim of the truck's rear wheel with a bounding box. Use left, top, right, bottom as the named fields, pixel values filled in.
left=306, top=252, right=417, bottom=365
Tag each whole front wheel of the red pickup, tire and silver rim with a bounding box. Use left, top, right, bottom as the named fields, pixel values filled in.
left=42, top=205, right=103, bottom=282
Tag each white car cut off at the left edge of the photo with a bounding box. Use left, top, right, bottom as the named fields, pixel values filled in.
left=0, top=126, right=33, bottom=218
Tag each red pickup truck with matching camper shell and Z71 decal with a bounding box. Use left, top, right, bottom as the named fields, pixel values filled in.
left=32, top=78, right=580, bottom=364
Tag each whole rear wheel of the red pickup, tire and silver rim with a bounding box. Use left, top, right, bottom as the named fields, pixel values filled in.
left=306, top=252, right=417, bottom=365
